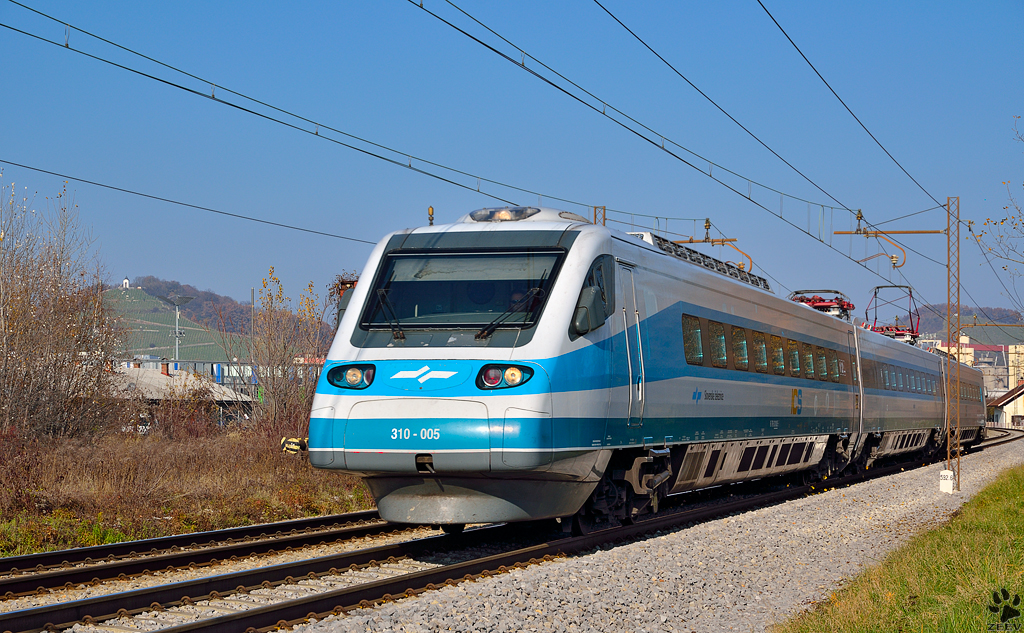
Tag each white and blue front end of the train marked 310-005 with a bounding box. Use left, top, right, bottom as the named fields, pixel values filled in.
left=309, top=212, right=608, bottom=523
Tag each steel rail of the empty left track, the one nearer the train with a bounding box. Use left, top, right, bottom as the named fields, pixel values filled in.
left=0, top=510, right=395, bottom=599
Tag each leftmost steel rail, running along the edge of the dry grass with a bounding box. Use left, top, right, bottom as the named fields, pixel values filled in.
left=0, top=510, right=380, bottom=573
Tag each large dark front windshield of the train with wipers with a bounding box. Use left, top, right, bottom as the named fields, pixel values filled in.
left=361, top=249, right=564, bottom=329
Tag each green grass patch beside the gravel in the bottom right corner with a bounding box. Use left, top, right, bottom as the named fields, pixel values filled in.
left=772, top=468, right=1024, bottom=633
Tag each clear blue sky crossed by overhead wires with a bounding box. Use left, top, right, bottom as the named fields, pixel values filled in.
left=0, top=0, right=1024, bottom=323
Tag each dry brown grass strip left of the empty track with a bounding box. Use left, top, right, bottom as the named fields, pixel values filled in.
left=0, top=433, right=373, bottom=555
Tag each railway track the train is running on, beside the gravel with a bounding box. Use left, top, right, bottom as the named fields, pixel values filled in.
left=0, top=429, right=1024, bottom=633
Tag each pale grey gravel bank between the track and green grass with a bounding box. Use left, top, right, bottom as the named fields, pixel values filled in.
left=296, top=441, right=1024, bottom=633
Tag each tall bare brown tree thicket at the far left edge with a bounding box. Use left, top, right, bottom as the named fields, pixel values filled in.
left=0, top=176, right=122, bottom=436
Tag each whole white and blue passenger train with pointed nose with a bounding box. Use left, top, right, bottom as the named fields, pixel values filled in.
left=308, top=207, right=985, bottom=533
